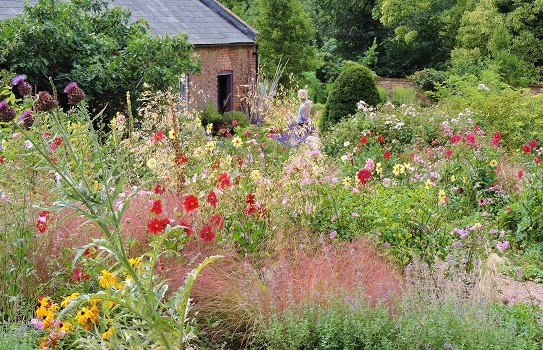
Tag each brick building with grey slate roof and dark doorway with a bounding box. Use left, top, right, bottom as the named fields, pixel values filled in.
left=0, top=0, right=258, bottom=111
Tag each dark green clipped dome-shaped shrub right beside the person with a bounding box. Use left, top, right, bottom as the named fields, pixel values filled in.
left=321, top=63, right=381, bottom=131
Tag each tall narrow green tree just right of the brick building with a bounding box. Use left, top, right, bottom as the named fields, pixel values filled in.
left=257, top=0, right=316, bottom=86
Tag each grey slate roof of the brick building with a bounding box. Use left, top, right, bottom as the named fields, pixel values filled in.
left=0, top=0, right=257, bottom=45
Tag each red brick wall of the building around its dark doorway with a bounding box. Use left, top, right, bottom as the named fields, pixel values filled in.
left=189, top=45, right=257, bottom=110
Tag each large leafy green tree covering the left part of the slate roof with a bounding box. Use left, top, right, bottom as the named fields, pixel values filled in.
left=0, top=0, right=197, bottom=114
